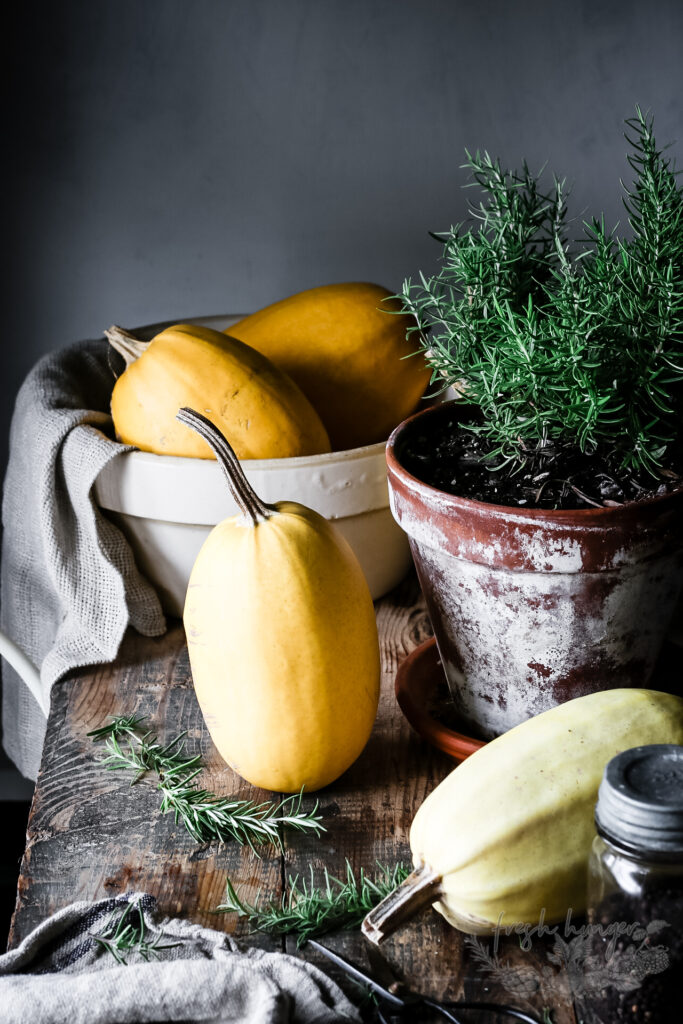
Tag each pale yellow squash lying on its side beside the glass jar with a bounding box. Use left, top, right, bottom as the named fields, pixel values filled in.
left=362, top=689, right=683, bottom=942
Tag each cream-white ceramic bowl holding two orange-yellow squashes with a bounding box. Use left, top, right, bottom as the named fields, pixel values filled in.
left=94, top=315, right=411, bottom=615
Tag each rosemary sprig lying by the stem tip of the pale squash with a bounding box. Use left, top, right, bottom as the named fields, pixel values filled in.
left=216, top=860, right=410, bottom=947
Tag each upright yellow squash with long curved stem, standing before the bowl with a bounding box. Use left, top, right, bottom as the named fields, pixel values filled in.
left=178, top=409, right=380, bottom=793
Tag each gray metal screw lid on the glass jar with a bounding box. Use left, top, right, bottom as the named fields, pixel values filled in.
left=595, top=743, right=683, bottom=858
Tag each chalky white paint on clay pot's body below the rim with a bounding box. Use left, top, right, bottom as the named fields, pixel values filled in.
left=416, top=547, right=683, bottom=738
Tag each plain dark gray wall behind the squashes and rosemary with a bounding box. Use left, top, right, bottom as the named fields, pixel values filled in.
left=0, top=0, right=683, bottom=461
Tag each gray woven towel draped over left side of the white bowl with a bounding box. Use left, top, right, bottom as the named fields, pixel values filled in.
left=0, top=339, right=166, bottom=779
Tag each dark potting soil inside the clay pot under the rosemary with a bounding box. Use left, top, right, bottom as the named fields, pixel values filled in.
left=400, top=409, right=683, bottom=509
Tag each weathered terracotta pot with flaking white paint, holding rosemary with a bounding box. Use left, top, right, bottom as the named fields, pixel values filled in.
left=387, top=407, right=683, bottom=738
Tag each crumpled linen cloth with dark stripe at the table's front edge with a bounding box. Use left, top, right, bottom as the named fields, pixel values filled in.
left=0, top=893, right=360, bottom=1024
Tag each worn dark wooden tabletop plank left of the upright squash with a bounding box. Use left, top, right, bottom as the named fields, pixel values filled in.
left=9, top=625, right=281, bottom=946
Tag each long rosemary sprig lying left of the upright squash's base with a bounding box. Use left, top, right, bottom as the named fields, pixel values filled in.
left=88, top=715, right=325, bottom=853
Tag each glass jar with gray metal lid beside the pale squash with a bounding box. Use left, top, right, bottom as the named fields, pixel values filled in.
left=574, top=744, right=683, bottom=1024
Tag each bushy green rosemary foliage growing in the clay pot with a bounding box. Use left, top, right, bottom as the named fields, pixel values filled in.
left=399, top=109, right=683, bottom=476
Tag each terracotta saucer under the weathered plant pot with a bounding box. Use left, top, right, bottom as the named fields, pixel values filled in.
left=395, top=637, right=484, bottom=761
